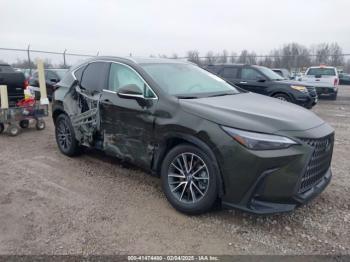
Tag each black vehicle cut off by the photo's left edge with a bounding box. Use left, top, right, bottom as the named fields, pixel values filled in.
left=0, top=64, right=28, bottom=107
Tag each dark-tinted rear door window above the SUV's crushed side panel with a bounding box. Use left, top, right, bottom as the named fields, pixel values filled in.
left=81, top=62, right=110, bottom=93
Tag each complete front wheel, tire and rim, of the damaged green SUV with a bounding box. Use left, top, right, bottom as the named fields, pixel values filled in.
left=161, top=144, right=219, bottom=215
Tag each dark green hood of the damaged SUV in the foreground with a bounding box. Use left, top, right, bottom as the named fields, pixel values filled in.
left=180, top=93, right=324, bottom=133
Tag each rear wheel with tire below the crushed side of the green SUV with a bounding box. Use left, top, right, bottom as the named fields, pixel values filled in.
left=55, top=114, right=81, bottom=156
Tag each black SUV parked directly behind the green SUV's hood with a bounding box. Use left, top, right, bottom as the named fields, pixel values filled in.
left=205, top=64, right=318, bottom=109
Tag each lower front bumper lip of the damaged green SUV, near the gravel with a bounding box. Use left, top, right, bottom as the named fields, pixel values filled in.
left=222, top=168, right=332, bottom=215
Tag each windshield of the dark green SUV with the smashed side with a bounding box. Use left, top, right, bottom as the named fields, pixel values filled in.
left=141, top=63, right=239, bottom=98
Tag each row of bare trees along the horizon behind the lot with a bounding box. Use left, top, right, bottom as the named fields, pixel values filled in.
left=4, top=43, right=350, bottom=73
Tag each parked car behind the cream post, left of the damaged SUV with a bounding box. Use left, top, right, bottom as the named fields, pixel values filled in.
left=29, top=69, right=68, bottom=99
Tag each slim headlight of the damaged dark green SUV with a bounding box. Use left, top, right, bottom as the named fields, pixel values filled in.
left=222, top=126, right=298, bottom=150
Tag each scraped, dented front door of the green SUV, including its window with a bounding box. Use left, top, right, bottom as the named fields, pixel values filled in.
left=100, top=63, right=157, bottom=168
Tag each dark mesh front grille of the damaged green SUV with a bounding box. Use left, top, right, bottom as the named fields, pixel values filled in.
left=298, top=134, right=334, bottom=193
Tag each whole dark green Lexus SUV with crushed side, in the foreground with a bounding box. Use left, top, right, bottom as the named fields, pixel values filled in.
left=52, top=57, right=334, bottom=214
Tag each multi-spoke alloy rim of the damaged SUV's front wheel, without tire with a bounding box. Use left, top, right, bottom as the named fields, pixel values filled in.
left=168, top=152, right=209, bottom=203
